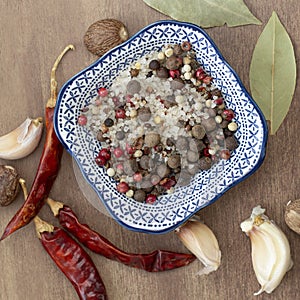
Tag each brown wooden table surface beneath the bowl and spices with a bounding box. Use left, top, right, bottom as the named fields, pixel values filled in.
left=0, top=0, right=300, bottom=300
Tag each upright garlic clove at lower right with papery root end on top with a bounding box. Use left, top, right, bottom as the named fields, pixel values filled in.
left=240, top=206, right=293, bottom=296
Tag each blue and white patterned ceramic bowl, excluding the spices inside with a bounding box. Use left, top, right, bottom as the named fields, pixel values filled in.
left=54, top=21, right=267, bottom=233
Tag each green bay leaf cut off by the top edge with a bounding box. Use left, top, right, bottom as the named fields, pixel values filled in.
left=143, top=0, right=261, bottom=28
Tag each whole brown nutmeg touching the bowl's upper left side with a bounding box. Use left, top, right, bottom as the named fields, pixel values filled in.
left=83, top=19, right=129, bottom=56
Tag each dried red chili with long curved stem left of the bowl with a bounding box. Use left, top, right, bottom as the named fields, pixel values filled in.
left=1, top=45, right=74, bottom=240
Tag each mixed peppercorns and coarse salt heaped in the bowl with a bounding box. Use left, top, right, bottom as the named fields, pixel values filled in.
left=78, top=42, right=238, bottom=203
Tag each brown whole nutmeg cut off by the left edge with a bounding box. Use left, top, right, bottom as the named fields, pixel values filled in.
left=0, top=165, right=20, bottom=206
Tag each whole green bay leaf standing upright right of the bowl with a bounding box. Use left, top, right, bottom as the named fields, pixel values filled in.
left=249, top=12, right=296, bottom=135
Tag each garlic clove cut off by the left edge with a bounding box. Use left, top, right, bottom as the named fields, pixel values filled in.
left=0, top=118, right=43, bottom=160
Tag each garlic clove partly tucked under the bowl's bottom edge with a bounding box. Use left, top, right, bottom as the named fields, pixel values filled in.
left=175, top=218, right=221, bottom=275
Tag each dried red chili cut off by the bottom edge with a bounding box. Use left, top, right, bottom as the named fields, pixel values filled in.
left=34, top=216, right=107, bottom=300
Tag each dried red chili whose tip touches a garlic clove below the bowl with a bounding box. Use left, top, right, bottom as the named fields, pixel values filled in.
left=47, top=198, right=196, bottom=272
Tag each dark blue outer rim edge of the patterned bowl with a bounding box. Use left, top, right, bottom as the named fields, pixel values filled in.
left=54, top=20, right=268, bottom=234
